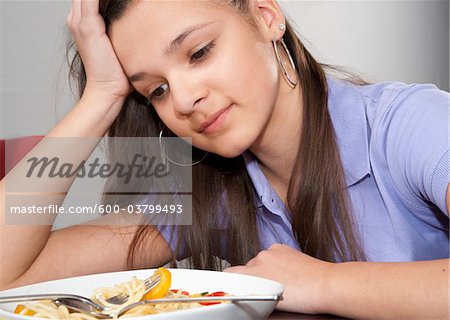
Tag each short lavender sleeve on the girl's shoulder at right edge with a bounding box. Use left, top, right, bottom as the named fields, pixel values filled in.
left=379, top=84, right=450, bottom=215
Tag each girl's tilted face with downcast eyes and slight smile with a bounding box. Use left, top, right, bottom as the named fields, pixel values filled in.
left=110, top=0, right=280, bottom=157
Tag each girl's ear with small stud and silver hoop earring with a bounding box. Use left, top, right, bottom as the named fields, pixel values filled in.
left=250, top=0, right=286, bottom=41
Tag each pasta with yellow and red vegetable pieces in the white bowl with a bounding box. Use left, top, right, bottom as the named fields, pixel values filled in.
left=15, top=268, right=227, bottom=320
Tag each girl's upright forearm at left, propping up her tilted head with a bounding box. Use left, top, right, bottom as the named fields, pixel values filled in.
left=0, top=92, right=123, bottom=286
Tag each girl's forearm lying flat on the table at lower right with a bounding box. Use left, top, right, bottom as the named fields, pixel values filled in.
left=323, top=259, right=449, bottom=319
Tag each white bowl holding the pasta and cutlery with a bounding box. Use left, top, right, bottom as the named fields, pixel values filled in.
left=0, top=269, right=284, bottom=320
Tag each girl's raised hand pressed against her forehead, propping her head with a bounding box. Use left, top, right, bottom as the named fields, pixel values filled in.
left=67, top=0, right=131, bottom=99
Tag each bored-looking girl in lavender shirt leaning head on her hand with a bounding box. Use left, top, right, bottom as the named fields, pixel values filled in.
left=1, top=0, right=450, bottom=319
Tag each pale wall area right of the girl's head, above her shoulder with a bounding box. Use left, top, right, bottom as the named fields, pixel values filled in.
left=281, top=0, right=449, bottom=86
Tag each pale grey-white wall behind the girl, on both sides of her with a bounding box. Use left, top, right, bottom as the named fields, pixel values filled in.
left=0, top=0, right=449, bottom=138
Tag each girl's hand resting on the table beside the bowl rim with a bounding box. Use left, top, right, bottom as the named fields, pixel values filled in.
left=224, top=244, right=333, bottom=313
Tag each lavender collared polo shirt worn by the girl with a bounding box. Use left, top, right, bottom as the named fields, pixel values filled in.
left=161, top=78, right=450, bottom=261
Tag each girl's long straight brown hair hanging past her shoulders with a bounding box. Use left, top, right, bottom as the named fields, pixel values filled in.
left=70, top=0, right=365, bottom=270
